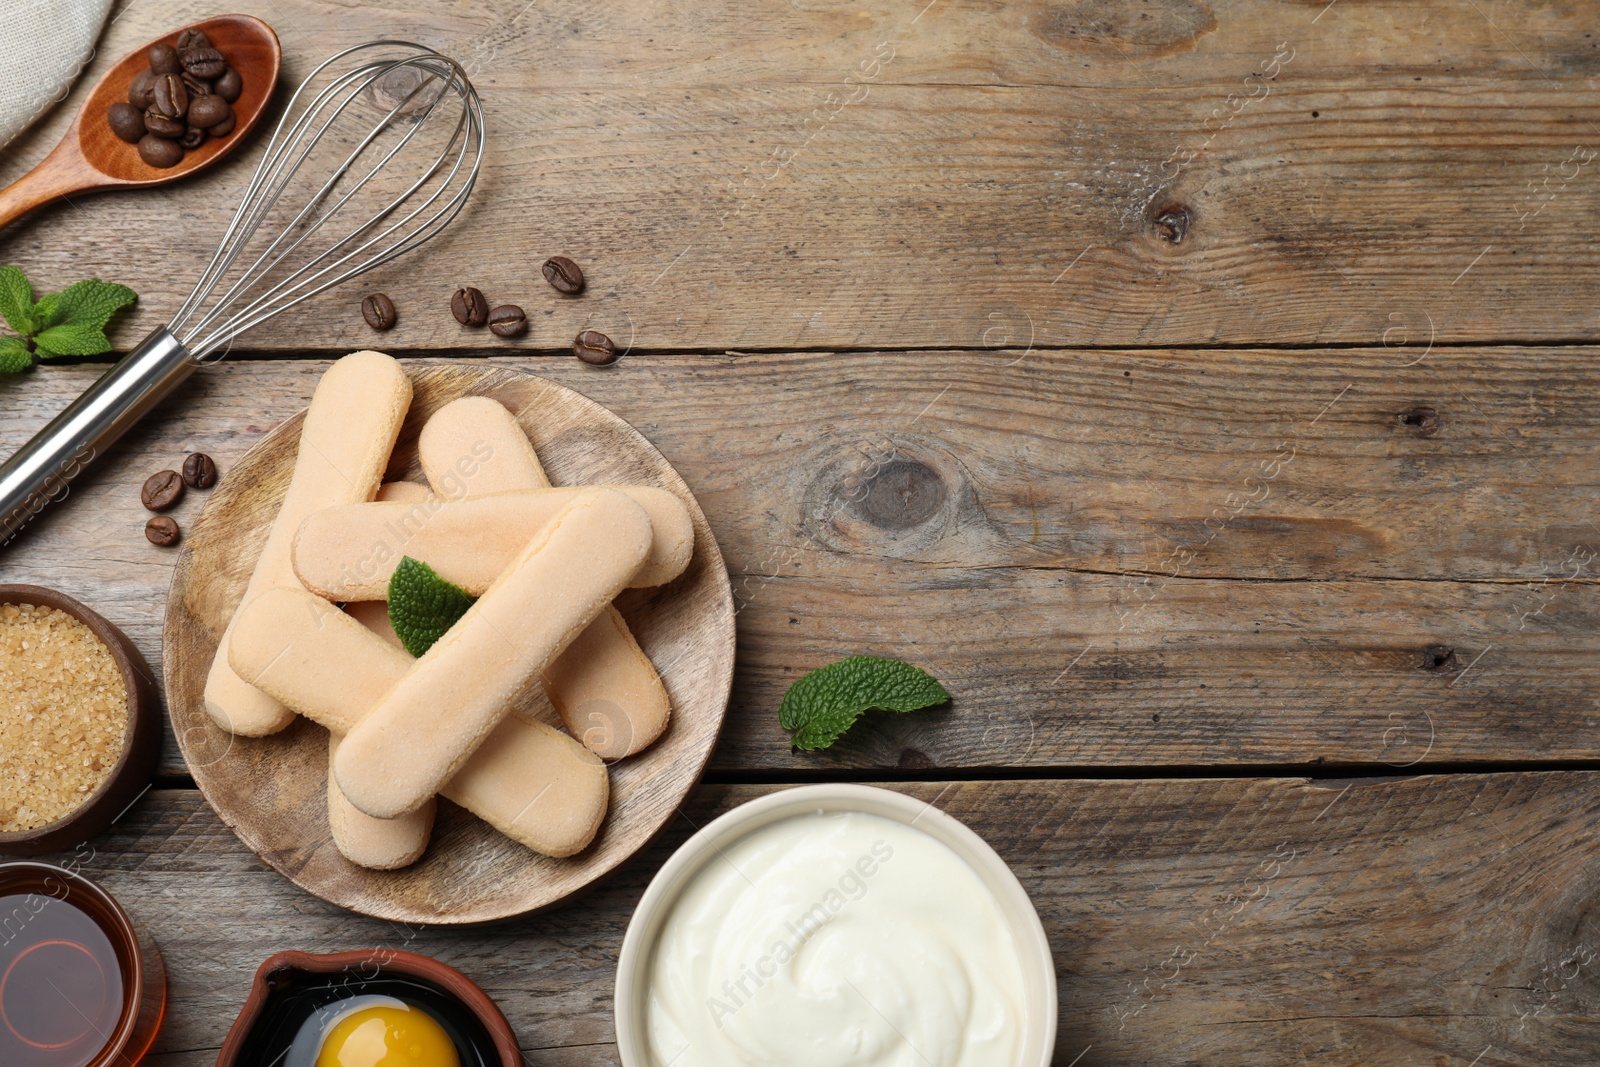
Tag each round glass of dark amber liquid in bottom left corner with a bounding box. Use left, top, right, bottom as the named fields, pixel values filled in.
left=0, top=862, right=166, bottom=1067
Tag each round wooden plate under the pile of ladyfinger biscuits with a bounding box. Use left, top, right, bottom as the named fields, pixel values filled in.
left=163, top=363, right=734, bottom=923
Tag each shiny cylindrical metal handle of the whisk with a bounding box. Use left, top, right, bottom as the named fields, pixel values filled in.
left=0, top=326, right=200, bottom=544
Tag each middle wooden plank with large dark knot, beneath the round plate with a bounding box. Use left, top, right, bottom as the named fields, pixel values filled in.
left=0, top=349, right=1600, bottom=774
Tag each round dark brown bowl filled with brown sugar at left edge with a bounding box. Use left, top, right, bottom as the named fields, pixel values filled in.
left=0, top=585, right=162, bottom=854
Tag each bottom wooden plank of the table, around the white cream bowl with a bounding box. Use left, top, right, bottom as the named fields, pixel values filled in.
left=34, top=773, right=1600, bottom=1067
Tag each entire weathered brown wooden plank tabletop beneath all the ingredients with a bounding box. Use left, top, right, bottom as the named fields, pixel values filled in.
left=0, top=0, right=1600, bottom=1067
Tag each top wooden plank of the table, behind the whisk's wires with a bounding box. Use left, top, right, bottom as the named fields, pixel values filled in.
left=0, top=0, right=1600, bottom=352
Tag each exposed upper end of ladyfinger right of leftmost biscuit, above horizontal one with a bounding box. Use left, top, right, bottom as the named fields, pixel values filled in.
left=416, top=397, right=550, bottom=501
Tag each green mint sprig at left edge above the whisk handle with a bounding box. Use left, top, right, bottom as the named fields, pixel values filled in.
left=0, top=267, right=139, bottom=374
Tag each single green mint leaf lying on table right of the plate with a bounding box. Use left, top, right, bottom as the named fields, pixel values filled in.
left=777, top=655, right=950, bottom=752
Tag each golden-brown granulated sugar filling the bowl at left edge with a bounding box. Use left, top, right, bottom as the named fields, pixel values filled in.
left=0, top=605, right=128, bottom=833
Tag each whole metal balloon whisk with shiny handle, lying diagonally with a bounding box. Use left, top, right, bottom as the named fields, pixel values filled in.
left=0, top=40, right=483, bottom=544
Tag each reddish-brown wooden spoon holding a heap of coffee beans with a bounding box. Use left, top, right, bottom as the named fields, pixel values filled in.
left=0, top=14, right=283, bottom=226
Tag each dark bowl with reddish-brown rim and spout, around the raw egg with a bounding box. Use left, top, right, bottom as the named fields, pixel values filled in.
left=216, top=949, right=523, bottom=1067
